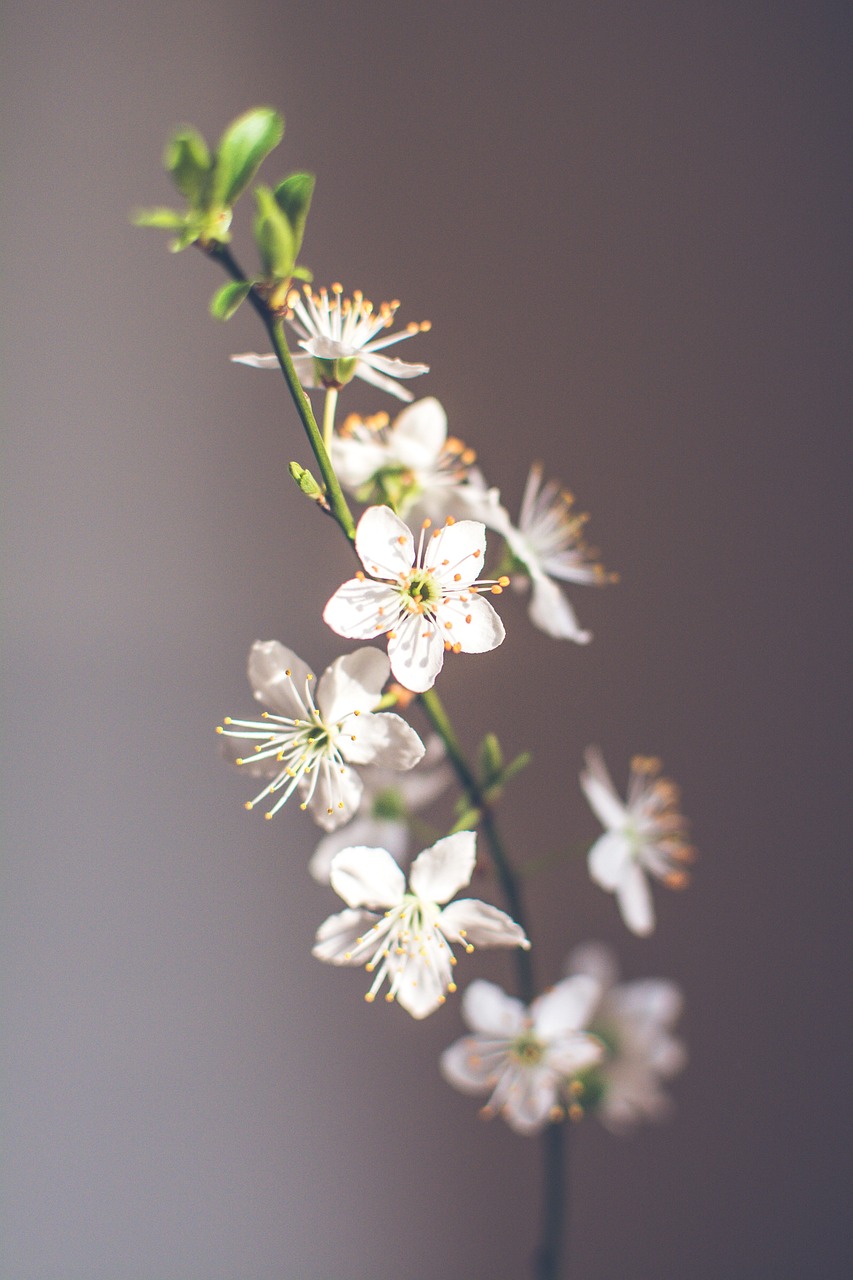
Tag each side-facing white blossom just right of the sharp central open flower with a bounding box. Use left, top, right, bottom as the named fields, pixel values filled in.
left=482, top=463, right=607, bottom=644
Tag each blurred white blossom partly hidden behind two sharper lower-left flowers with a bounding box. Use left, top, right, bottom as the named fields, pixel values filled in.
left=309, top=733, right=453, bottom=884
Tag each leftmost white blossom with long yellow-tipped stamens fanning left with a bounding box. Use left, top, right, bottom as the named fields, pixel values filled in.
left=216, top=640, right=424, bottom=831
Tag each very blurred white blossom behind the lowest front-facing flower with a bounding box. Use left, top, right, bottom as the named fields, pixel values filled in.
left=566, top=943, right=686, bottom=1133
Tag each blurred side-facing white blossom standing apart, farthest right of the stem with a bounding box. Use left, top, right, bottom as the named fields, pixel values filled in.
left=580, top=748, right=695, bottom=936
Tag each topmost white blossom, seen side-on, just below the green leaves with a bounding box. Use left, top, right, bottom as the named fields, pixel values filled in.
left=231, top=284, right=429, bottom=401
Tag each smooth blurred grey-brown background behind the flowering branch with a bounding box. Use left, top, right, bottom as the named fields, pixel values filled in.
left=0, top=0, right=853, bottom=1280
